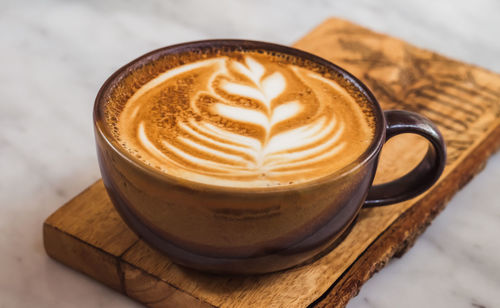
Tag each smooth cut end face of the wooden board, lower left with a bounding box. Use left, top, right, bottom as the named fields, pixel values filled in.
left=43, top=220, right=214, bottom=308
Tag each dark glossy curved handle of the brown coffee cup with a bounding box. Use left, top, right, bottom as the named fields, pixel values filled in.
left=363, top=110, right=446, bottom=207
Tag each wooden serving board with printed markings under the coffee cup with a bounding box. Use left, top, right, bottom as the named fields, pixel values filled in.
left=43, top=19, right=500, bottom=307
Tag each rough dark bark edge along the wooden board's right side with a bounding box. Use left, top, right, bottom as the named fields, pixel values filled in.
left=310, top=124, right=500, bottom=308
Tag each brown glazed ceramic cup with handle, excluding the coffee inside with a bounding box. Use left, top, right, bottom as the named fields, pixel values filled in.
left=94, top=40, right=446, bottom=274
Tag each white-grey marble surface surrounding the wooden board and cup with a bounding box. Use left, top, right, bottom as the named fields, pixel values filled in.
left=0, top=0, right=500, bottom=308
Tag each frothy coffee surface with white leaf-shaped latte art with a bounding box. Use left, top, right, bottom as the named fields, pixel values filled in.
left=108, top=51, right=374, bottom=187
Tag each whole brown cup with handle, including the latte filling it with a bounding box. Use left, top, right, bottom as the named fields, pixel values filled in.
left=94, top=40, right=446, bottom=274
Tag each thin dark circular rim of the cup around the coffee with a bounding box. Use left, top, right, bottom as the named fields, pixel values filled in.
left=93, top=39, right=386, bottom=194
